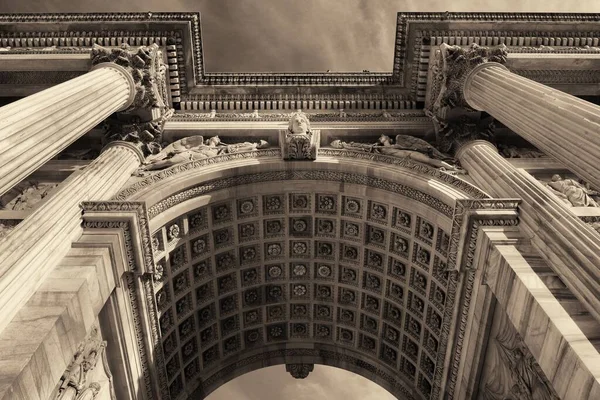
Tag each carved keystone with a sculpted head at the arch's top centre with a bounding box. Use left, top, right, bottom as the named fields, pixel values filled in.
left=279, top=111, right=320, bottom=161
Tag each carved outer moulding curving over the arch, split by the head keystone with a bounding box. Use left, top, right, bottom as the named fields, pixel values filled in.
left=112, top=148, right=489, bottom=202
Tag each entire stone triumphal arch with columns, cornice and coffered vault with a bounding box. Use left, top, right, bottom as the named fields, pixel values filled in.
left=0, top=13, right=600, bottom=400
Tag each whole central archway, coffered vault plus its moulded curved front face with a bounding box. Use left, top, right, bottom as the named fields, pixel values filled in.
left=111, top=151, right=496, bottom=399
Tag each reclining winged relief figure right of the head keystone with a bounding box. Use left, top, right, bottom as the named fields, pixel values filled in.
left=330, top=135, right=463, bottom=173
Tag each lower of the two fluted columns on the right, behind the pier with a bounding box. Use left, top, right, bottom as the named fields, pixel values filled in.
left=456, top=140, right=600, bottom=321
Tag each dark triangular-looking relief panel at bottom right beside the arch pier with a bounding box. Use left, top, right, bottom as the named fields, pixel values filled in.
left=477, top=307, right=559, bottom=400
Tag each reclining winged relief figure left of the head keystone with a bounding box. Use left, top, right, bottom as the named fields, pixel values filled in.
left=140, top=136, right=269, bottom=171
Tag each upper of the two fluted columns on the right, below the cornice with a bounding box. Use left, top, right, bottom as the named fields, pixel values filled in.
left=463, top=62, right=600, bottom=191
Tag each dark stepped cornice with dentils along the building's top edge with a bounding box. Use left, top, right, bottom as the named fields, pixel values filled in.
left=0, top=12, right=600, bottom=108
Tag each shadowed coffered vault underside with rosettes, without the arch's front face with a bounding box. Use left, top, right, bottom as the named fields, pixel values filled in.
left=153, top=181, right=459, bottom=399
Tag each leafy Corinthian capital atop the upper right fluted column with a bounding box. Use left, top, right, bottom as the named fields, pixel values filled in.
left=427, top=43, right=507, bottom=119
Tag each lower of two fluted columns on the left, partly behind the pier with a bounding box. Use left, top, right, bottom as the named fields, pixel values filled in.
left=0, top=142, right=144, bottom=332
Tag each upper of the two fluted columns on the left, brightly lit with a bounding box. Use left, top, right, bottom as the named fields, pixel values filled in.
left=0, top=63, right=135, bottom=195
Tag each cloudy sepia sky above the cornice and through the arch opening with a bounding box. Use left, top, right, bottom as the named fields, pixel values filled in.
left=0, top=0, right=600, bottom=400
